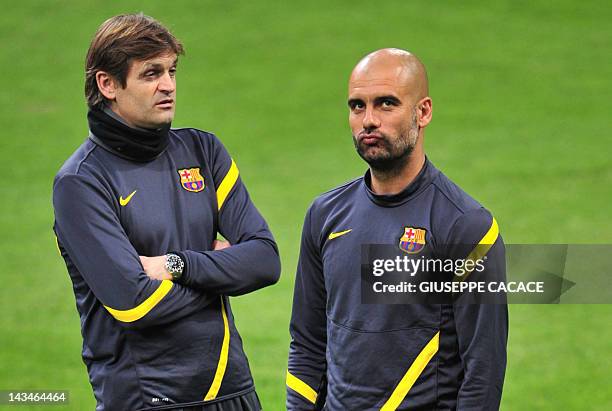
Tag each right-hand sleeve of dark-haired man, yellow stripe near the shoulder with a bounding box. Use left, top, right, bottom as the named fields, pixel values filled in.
left=178, top=135, right=280, bottom=296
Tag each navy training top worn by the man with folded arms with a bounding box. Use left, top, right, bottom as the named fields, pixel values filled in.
left=53, top=128, right=280, bottom=411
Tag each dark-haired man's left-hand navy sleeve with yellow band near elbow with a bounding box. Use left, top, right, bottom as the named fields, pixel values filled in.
left=53, top=174, right=215, bottom=328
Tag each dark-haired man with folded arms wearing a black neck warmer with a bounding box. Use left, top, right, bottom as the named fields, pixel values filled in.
left=53, top=14, right=280, bottom=411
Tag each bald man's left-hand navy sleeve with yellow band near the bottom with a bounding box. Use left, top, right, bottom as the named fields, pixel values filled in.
left=286, top=207, right=327, bottom=411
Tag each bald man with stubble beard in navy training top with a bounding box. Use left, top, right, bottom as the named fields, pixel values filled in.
left=287, top=49, right=508, bottom=411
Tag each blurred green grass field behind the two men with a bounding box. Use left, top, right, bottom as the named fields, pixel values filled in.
left=0, top=0, right=612, bottom=411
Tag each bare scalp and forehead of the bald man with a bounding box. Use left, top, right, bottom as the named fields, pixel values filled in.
left=349, top=48, right=429, bottom=100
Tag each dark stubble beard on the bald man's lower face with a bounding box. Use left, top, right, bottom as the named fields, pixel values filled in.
left=353, top=109, right=419, bottom=178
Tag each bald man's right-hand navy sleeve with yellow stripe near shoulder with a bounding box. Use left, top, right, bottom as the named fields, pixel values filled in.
left=449, top=208, right=508, bottom=411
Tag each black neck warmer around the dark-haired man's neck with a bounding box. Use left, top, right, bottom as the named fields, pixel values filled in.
left=87, top=109, right=170, bottom=162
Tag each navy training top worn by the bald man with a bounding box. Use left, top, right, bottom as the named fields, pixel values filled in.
left=287, top=160, right=508, bottom=411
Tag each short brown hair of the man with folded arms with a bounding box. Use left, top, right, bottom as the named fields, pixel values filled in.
left=85, top=13, right=184, bottom=108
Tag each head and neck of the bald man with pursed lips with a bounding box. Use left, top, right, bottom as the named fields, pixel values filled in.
left=348, top=49, right=432, bottom=187
